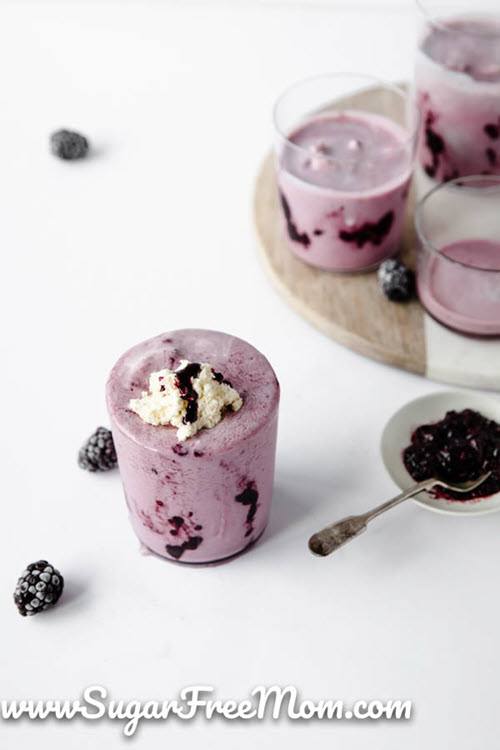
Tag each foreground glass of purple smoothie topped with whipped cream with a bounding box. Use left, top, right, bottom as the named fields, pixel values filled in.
left=106, top=329, right=279, bottom=563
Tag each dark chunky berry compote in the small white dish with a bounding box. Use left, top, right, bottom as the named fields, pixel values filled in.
left=403, top=409, right=500, bottom=500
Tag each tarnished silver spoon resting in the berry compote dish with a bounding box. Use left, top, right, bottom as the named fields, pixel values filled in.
left=309, top=471, right=491, bottom=557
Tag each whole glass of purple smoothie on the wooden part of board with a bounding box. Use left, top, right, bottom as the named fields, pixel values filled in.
left=274, top=73, right=418, bottom=271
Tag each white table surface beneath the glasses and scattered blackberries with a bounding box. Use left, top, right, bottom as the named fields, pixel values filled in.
left=0, top=2, right=500, bottom=750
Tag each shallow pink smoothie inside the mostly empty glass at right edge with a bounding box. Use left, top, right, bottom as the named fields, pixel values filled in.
left=417, top=238, right=500, bottom=335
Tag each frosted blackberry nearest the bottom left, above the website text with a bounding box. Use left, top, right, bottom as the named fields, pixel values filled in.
left=14, top=560, right=64, bottom=617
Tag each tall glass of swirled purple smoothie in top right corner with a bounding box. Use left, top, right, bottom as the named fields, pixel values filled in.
left=415, top=0, right=500, bottom=182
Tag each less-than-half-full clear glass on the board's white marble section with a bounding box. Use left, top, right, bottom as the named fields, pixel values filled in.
left=415, top=175, right=500, bottom=336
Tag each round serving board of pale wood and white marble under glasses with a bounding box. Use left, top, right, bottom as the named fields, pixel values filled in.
left=254, top=90, right=500, bottom=390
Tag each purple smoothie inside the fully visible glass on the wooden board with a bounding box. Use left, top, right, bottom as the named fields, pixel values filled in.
left=277, top=110, right=412, bottom=271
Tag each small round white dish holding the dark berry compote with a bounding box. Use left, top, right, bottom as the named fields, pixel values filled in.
left=380, top=391, right=500, bottom=516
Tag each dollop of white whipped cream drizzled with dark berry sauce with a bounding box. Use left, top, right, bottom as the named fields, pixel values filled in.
left=129, top=359, right=243, bottom=441
